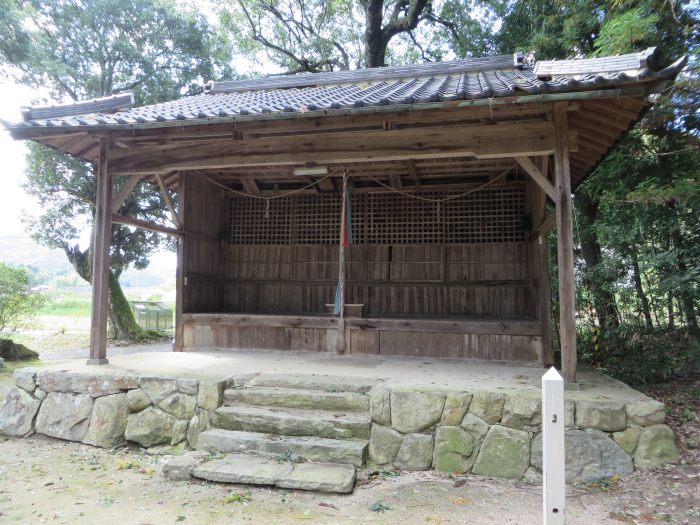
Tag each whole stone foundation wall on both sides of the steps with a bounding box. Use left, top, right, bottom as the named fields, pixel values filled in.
left=0, top=368, right=678, bottom=481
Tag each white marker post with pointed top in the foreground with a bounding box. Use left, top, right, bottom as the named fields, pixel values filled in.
left=542, top=367, right=566, bottom=525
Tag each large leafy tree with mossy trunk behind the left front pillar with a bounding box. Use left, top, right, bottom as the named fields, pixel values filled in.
left=0, top=0, right=230, bottom=339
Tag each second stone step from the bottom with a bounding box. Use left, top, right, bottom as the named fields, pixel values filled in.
left=197, top=429, right=367, bottom=467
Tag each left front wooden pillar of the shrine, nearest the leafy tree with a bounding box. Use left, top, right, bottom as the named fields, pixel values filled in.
left=87, top=138, right=113, bottom=365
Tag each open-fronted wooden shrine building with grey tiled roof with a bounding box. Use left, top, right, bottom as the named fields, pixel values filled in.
left=5, top=49, right=685, bottom=381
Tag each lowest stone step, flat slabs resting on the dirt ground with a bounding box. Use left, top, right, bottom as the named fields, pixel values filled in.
left=191, top=454, right=355, bottom=494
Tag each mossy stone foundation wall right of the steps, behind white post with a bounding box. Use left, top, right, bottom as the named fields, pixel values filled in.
left=369, top=388, right=678, bottom=481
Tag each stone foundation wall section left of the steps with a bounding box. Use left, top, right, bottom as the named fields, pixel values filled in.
left=0, top=368, right=227, bottom=448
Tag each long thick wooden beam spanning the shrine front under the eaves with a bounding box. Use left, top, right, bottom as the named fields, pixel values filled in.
left=113, top=122, right=576, bottom=175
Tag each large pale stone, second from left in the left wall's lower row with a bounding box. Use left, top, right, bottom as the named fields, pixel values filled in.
left=36, top=392, right=94, bottom=441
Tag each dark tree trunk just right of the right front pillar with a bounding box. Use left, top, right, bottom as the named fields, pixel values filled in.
left=577, top=192, right=620, bottom=329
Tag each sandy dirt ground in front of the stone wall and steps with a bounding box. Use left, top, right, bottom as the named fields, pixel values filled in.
left=0, top=436, right=700, bottom=525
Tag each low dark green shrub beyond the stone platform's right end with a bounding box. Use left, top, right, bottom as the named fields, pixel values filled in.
left=578, top=325, right=700, bottom=386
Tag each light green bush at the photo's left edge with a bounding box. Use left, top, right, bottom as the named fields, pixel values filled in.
left=0, top=262, right=44, bottom=332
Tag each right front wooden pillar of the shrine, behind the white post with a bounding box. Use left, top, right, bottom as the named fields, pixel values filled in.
left=554, top=102, right=576, bottom=383
